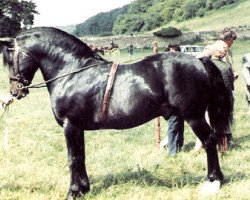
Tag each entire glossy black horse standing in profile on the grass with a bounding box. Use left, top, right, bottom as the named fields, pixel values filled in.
left=1, top=28, right=232, bottom=198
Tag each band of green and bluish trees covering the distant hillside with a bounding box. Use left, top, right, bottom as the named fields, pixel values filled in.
left=75, top=0, right=240, bottom=36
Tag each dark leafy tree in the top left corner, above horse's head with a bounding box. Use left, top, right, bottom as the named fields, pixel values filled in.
left=0, top=0, right=38, bottom=37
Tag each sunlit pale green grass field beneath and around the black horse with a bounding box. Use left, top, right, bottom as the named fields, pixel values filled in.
left=0, top=38, right=250, bottom=200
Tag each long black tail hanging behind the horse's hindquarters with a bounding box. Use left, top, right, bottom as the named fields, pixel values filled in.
left=200, top=58, right=233, bottom=152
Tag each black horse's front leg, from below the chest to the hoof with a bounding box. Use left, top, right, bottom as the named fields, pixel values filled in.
left=64, top=121, right=90, bottom=199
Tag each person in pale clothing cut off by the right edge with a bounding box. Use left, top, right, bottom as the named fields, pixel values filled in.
left=242, top=53, right=250, bottom=115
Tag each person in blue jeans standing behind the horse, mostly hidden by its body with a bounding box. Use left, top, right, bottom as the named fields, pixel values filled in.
left=160, top=44, right=184, bottom=156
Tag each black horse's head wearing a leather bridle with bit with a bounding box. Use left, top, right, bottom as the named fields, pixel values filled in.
left=0, top=38, right=36, bottom=99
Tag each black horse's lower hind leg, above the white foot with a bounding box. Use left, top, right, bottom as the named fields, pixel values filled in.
left=187, top=118, right=223, bottom=182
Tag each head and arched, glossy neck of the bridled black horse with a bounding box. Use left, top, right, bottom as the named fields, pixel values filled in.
left=0, top=27, right=106, bottom=99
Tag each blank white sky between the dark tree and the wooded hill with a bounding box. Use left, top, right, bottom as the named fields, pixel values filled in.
left=31, top=0, right=133, bottom=26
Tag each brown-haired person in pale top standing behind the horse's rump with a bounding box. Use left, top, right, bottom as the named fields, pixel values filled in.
left=195, top=28, right=238, bottom=151
